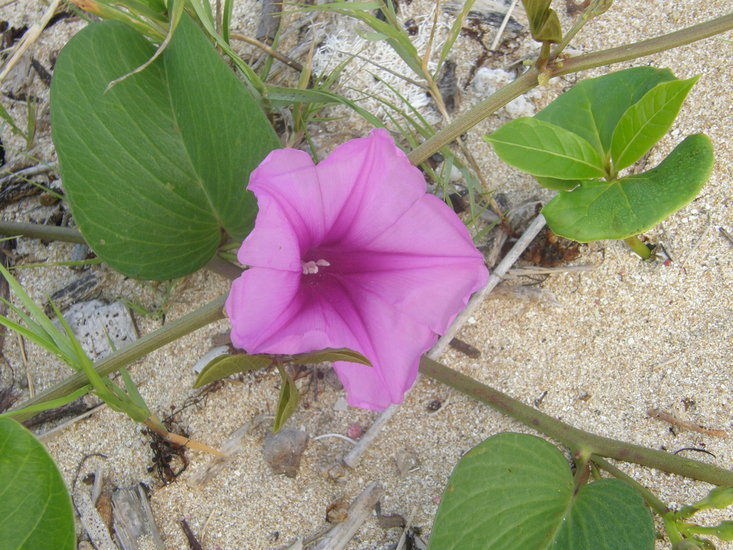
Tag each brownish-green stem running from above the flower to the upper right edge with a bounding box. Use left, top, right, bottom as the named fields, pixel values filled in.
left=408, top=13, right=733, bottom=165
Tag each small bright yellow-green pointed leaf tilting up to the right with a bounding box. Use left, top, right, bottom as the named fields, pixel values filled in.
left=611, top=77, right=698, bottom=171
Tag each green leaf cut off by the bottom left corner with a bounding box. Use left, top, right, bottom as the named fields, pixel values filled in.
left=0, top=418, right=76, bottom=550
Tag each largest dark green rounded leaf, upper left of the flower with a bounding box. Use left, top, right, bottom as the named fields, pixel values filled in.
left=51, top=16, right=279, bottom=279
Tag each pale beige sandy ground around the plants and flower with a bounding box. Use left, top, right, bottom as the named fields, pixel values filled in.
left=0, top=0, right=733, bottom=549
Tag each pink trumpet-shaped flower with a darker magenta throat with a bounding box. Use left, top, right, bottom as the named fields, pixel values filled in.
left=226, top=130, right=488, bottom=410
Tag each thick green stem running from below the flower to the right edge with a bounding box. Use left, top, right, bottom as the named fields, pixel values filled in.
left=420, top=356, right=733, bottom=487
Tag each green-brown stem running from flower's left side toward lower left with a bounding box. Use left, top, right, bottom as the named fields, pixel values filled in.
left=8, top=295, right=226, bottom=422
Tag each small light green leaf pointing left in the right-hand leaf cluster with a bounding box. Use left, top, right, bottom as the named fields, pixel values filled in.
left=485, top=118, right=606, bottom=179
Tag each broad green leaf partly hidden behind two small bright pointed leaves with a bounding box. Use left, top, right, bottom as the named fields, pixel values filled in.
left=534, top=67, right=674, bottom=159
